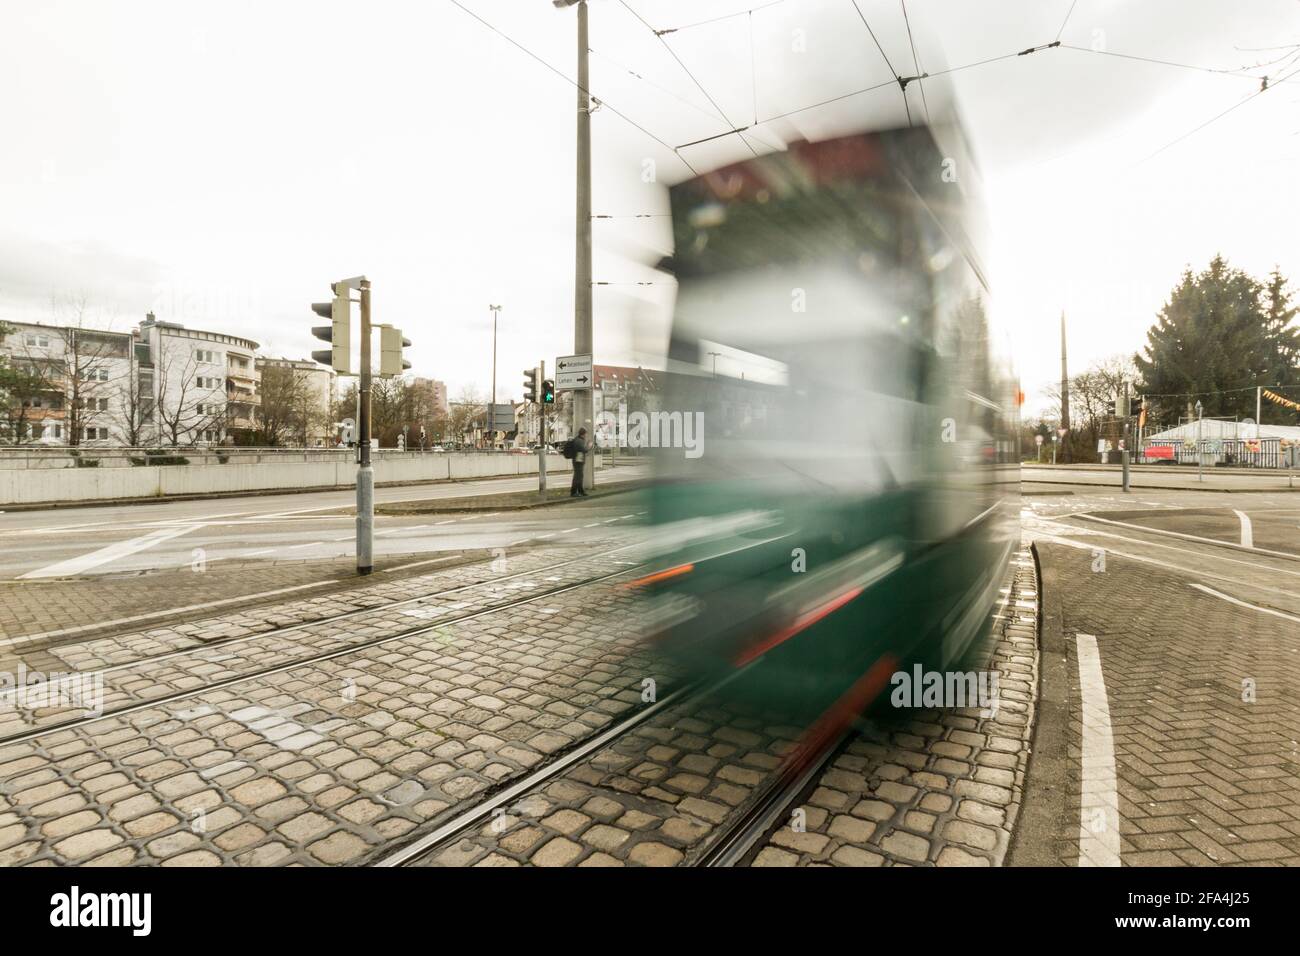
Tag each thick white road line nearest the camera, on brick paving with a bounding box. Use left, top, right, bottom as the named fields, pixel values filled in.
left=1075, top=633, right=1119, bottom=866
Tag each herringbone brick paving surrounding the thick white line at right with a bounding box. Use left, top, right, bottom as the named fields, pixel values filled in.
left=1031, top=532, right=1300, bottom=866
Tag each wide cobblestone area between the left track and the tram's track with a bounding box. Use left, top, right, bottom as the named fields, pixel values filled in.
left=0, top=546, right=675, bottom=865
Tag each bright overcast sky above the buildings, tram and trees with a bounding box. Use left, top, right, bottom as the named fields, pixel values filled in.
left=0, top=0, right=1300, bottom=410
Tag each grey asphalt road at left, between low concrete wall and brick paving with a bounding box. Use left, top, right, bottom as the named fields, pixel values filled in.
left=0, top=467, right=644, bottom=580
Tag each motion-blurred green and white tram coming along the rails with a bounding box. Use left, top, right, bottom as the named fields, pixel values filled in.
left=637, top=119, right=1019, bottom=705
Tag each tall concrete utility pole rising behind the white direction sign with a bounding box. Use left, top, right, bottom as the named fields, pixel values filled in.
left=573, top=0, right=595, bottom=488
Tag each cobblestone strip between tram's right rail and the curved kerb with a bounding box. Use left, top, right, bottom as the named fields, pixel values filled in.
left=754, top=550, right=1037, bottom=866
